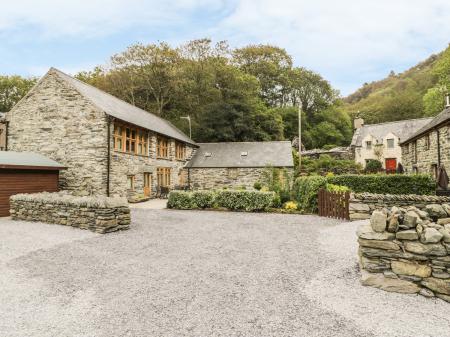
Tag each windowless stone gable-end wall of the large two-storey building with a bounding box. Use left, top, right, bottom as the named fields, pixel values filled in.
left=6, top=71, right=108, bottom=195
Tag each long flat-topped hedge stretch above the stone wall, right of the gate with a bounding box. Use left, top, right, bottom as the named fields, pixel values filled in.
left=327, top=174, right=436, bottom=195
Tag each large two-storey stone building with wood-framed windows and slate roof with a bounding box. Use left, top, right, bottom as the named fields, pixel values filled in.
left=6, top=68, right=198, bottom=196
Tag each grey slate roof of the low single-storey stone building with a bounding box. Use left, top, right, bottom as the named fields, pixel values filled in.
left=186, top=141, right=294, bottom=168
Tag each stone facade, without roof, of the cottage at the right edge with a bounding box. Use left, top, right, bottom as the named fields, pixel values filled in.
left=402, top=126, right=450, bottom=175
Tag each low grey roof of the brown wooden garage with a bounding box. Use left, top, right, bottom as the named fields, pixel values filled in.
left=0, top=151, right=65, bottom=170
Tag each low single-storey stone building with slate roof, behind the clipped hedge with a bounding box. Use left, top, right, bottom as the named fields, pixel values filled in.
left=186, top=141, right=294, bottom=189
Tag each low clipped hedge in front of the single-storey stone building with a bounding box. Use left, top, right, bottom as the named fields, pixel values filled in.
left=167, top=190, right=276, bottom=212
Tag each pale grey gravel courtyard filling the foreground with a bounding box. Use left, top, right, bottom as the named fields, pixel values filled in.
left=0, top=209, right=450, bottom=337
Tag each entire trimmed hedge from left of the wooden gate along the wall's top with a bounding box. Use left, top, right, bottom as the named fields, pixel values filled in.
left=294, top=174, right=436, bottom=213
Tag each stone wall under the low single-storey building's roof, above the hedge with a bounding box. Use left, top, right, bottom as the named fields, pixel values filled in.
left=189, top=167, right=293, bottom=190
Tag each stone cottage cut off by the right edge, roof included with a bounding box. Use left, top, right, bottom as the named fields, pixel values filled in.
left=401, top=98, right=450, bottom=181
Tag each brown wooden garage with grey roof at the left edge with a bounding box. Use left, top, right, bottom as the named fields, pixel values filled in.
left=0, top=151, right=65, bottom=217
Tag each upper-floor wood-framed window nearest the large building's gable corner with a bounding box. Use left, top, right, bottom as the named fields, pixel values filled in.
left=114, top=123, right=148, bottom=156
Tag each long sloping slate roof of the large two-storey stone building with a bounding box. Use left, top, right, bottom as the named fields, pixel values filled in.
left=50, top=68, right=195, bottom=145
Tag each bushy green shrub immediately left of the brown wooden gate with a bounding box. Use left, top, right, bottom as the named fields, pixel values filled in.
left=294, top=176, right=327, bottom=213
